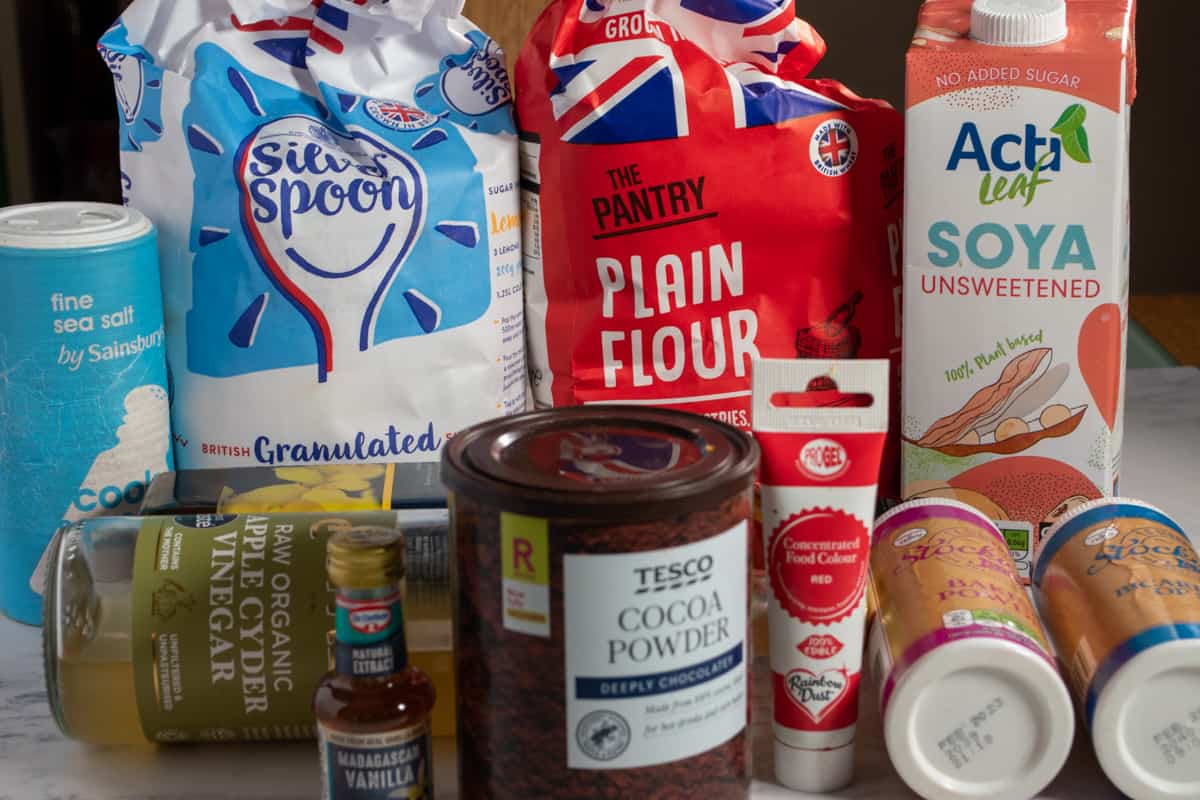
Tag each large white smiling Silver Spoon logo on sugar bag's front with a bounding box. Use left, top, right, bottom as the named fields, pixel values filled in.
left=235, top=116, right=426, bottom=381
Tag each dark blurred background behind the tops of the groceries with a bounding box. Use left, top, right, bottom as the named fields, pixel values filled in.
left=0, top=0, right=1200, bottom=298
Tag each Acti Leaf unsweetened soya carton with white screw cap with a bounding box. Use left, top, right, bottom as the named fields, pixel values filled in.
left=902, top=0, right=1135, bottom=578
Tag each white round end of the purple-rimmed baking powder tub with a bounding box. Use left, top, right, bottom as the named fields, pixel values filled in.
left=883, top=638, right=1075, bottom=800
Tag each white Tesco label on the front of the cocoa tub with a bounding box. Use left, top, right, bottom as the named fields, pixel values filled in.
left=563, top=523, right=749, bottom=770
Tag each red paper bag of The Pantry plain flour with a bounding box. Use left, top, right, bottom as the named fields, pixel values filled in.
left=516, top=0, right=902, bottom=496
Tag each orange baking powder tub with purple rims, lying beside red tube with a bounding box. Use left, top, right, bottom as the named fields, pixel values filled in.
left=868, top=500, right=1074, bottom=800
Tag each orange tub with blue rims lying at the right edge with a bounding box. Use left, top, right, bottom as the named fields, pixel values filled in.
left=1033, top=499, right=1200, bottom=800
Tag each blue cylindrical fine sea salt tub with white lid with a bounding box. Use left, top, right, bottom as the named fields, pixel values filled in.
left=0, top=203, right=172, bottom=624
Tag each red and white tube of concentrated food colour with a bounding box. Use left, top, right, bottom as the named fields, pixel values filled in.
left=752, top=360, right=889, bottom=792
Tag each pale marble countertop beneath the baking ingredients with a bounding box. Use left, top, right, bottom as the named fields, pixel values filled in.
left=0, top=368, right=1200, bottom=800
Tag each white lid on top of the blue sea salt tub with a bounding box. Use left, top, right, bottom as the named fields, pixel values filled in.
left=0, top=203, right=154, bottom=249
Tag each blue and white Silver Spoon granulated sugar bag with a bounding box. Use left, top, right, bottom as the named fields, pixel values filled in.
left=100, top=0, right=526, bottom=469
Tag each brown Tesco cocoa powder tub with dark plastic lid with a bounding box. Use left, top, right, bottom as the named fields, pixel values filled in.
left=442, top=407, right=758, bottom=800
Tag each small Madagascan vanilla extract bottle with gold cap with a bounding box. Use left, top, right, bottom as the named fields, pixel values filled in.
left=313, top=528, right=434, bottom=800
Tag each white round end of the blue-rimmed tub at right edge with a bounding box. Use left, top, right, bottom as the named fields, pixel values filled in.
left=1092, top=639, right=1200, bottom=800
